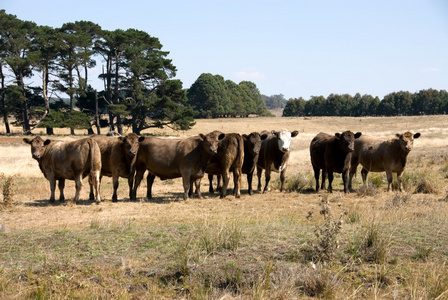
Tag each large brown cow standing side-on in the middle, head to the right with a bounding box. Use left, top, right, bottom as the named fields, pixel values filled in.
left=131, top=132, right=225, bottom=200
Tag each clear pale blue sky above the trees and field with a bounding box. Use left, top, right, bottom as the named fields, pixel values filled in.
left=0, top=0, right=448, bottom=100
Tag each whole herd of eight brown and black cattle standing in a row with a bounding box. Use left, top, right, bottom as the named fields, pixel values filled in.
left=23, top=129, right=420, bottom=204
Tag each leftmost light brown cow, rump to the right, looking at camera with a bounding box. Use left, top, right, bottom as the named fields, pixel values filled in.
left=23, top=136, right=101, bottom=204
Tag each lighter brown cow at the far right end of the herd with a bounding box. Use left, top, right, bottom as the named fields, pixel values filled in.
left=348, top=131, right=420, bottom=191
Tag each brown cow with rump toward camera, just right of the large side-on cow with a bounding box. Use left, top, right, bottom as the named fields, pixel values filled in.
left=205, top=132, right=244, bottom=198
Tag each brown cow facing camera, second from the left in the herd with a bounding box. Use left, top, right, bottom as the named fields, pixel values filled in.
left=90, top=133, right=145, bottom=202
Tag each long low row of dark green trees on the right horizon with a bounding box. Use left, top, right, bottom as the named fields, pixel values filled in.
left=283, top=89, right=448, bottom=117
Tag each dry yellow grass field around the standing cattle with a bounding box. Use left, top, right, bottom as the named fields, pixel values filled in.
left=0, top=116, right=448, bottom=299
